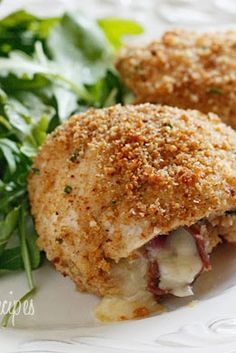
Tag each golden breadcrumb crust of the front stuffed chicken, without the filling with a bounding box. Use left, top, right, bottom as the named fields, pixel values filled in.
left=28, top=104, right=236, bottom=295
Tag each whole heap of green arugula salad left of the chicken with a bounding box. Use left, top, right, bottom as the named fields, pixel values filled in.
left=0, top=10, right=142, bottom=326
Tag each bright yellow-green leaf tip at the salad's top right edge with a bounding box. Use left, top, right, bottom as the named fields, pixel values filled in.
left=98, top=17, right=143, bottom=50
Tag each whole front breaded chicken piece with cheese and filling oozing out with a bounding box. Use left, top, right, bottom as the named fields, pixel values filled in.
left=28, top=104, right=236, bottom=320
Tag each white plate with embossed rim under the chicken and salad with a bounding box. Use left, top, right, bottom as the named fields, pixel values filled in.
left=0, top=0, right=236, bottom=353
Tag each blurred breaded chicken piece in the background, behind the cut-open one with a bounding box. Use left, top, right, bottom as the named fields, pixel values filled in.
left=116, top=30, right=236, bottom=128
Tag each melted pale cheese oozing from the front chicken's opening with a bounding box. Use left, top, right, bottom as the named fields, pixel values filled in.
left=95, top=228, right=202, bottom=321
